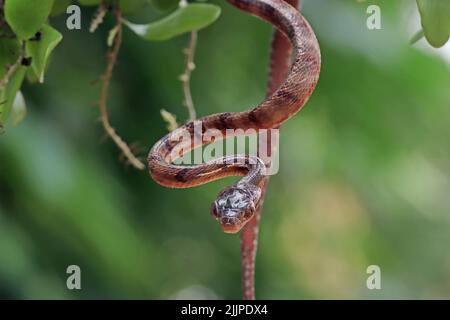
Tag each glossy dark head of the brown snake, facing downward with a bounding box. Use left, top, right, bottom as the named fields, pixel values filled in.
left=211, top=183, right=261, bottom=233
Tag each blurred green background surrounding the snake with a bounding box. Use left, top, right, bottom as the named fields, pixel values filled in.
left=0, top=0, right=450, bottom=299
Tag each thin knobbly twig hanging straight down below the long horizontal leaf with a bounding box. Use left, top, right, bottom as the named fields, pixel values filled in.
left=180, top=31, right=197, bottom=122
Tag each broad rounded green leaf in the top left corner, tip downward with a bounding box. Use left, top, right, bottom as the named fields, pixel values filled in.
left=5, top=0, right=53, bottom=40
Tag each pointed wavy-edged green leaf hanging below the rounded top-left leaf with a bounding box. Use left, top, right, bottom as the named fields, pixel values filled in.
left=27, top=24, right=62, bottom=83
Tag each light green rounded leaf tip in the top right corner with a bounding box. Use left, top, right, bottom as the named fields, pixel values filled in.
left=417, top=0, right=450, bottom=48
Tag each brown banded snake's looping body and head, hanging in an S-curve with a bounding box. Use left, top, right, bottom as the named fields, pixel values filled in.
left=148, top=0, right=321, bottom=297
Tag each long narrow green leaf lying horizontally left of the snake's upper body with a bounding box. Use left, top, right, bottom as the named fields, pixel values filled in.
left=124, top=3, right=220, bottom=41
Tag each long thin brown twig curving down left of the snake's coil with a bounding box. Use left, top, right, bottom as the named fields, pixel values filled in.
left=99, top=7, right=145, bottom=170
